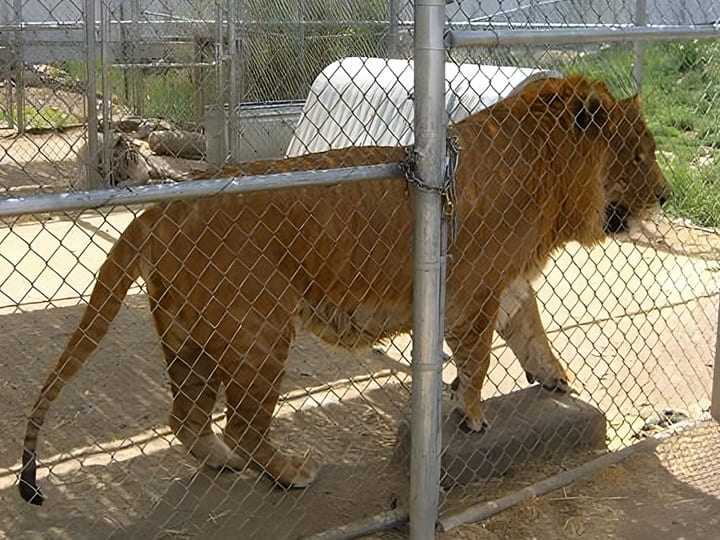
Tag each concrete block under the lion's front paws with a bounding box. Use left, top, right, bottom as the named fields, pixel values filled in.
left=394, top=385, right=606, bottom=487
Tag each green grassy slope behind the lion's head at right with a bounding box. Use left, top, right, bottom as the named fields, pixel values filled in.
left=562, top=40, right=720, bottom=227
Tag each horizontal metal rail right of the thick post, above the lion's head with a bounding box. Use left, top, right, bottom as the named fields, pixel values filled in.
left=445, top=25, right=720, bottom=49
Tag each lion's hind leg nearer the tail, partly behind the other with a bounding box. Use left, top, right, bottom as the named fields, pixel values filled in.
left=163, top=345, right=245, bottom=469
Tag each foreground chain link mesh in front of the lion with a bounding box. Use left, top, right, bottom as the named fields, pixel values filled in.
left=0, top=0, right=720, bottom=538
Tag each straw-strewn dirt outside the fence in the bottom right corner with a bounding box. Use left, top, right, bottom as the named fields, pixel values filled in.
left=428, top=421, right=720, bottom=540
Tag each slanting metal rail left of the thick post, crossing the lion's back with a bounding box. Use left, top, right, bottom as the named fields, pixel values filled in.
left=0, top=163, right=404, bottom=217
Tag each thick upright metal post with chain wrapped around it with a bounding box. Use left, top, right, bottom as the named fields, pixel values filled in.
left=409, top=0, right=446, bottom=540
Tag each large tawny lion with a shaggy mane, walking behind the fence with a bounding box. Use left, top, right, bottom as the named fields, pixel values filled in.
left=20, top=77, right=668, bottom=504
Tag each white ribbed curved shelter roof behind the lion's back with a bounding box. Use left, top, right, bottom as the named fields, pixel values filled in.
left=287, top=57, right=549, bottom=156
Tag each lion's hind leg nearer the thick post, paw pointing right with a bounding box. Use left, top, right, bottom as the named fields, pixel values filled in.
left=225, top=321, right=317, bottom=487
